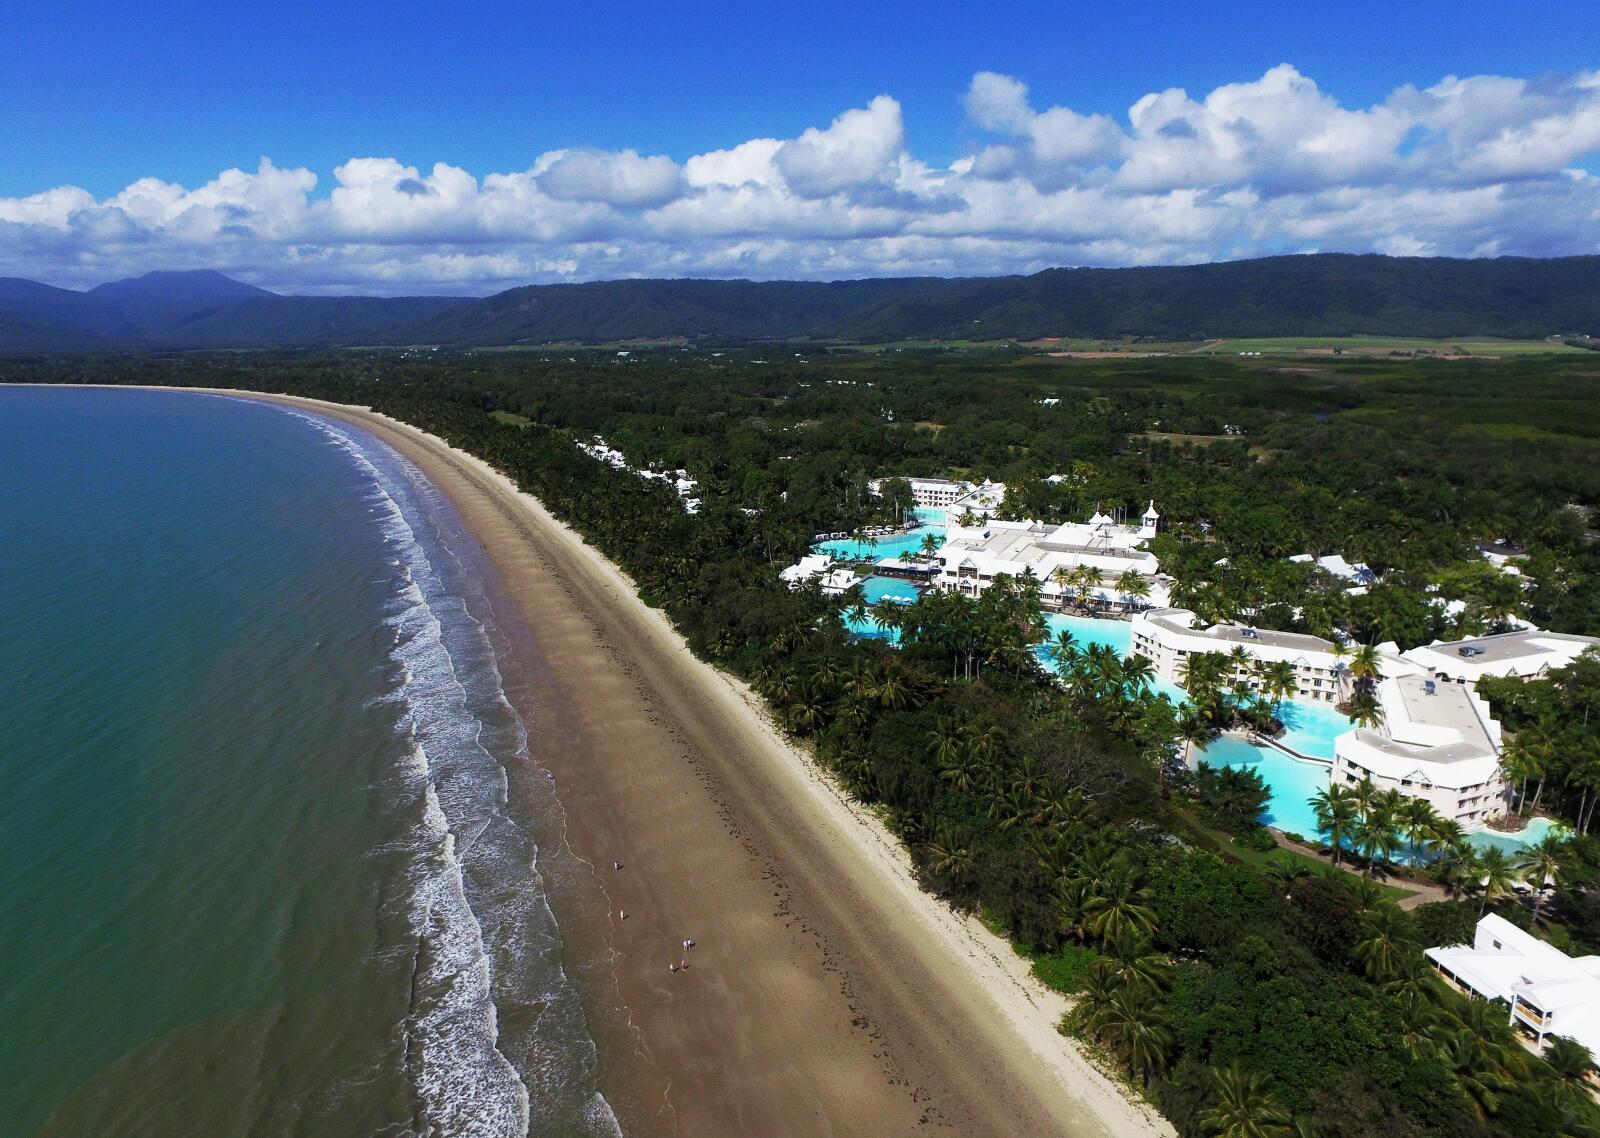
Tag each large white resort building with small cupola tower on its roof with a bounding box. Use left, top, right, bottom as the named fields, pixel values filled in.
left=933, top=503, right=1171, bottom=607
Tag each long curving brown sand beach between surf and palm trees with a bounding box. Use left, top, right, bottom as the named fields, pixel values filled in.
left=219, top=392, right=1171, bottom=1138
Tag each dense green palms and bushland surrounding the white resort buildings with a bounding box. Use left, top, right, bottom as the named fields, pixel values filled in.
left=12, top=354, right=1600, bottom=1138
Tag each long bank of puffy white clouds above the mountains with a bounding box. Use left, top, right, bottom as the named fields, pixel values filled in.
left=0, top=64, right=1600, bottom=293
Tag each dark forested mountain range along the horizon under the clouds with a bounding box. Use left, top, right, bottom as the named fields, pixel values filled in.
left=0, top=253, right=1600, bottom=354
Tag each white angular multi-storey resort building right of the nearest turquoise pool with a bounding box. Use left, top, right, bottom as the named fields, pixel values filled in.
left=1330, top=675, right=1510, bottom=831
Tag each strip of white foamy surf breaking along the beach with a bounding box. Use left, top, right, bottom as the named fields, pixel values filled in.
left=283, top=415, right=621, bottom=1138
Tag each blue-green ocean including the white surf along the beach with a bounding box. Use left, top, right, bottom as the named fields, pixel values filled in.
left=0, top=387, right=618, bottom=1138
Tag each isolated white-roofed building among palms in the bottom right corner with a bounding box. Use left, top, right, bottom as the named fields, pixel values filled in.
left=1427, top=914, right=1600, bottom=1055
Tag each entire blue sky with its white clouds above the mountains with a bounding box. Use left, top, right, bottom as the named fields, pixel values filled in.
left=0, top=2, right=1600, bottom=291
